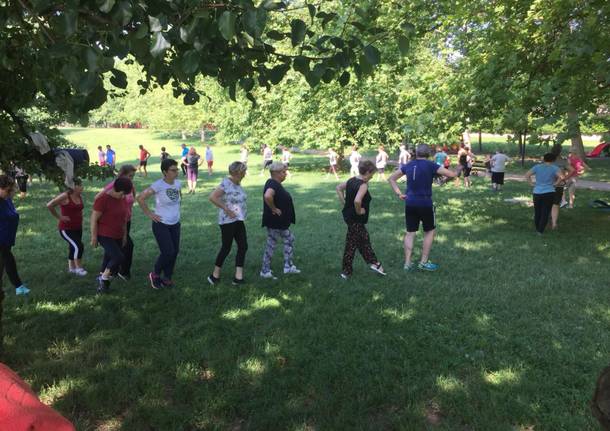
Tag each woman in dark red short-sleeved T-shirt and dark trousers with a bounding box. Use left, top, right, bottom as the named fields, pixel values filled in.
left=91, top=177, right=133, bottom=293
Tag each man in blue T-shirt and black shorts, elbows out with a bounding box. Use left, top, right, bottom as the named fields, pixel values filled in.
left=388, top=144, right=456, bottom=271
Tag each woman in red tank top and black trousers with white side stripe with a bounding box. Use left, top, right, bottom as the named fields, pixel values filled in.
left=47, top=178, right=87, bottom=276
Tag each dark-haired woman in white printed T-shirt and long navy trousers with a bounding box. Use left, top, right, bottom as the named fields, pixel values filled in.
left=136, top=159, right=182, bottom=289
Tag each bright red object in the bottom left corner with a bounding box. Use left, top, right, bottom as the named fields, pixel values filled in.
left=0, top=363, right=76, bottom=431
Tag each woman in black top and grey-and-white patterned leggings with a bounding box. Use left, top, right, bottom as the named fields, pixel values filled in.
left=260, top=162, right=301, bottom=279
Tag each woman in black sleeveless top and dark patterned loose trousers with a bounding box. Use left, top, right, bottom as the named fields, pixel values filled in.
left=337, top=160, right=385, bottom=279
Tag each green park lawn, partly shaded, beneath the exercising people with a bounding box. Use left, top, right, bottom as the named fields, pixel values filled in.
left=4, top=129, right=610, bottom=431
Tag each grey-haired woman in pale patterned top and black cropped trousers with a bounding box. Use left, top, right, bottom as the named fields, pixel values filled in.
left=208, top=162, right=248, bottom=285
